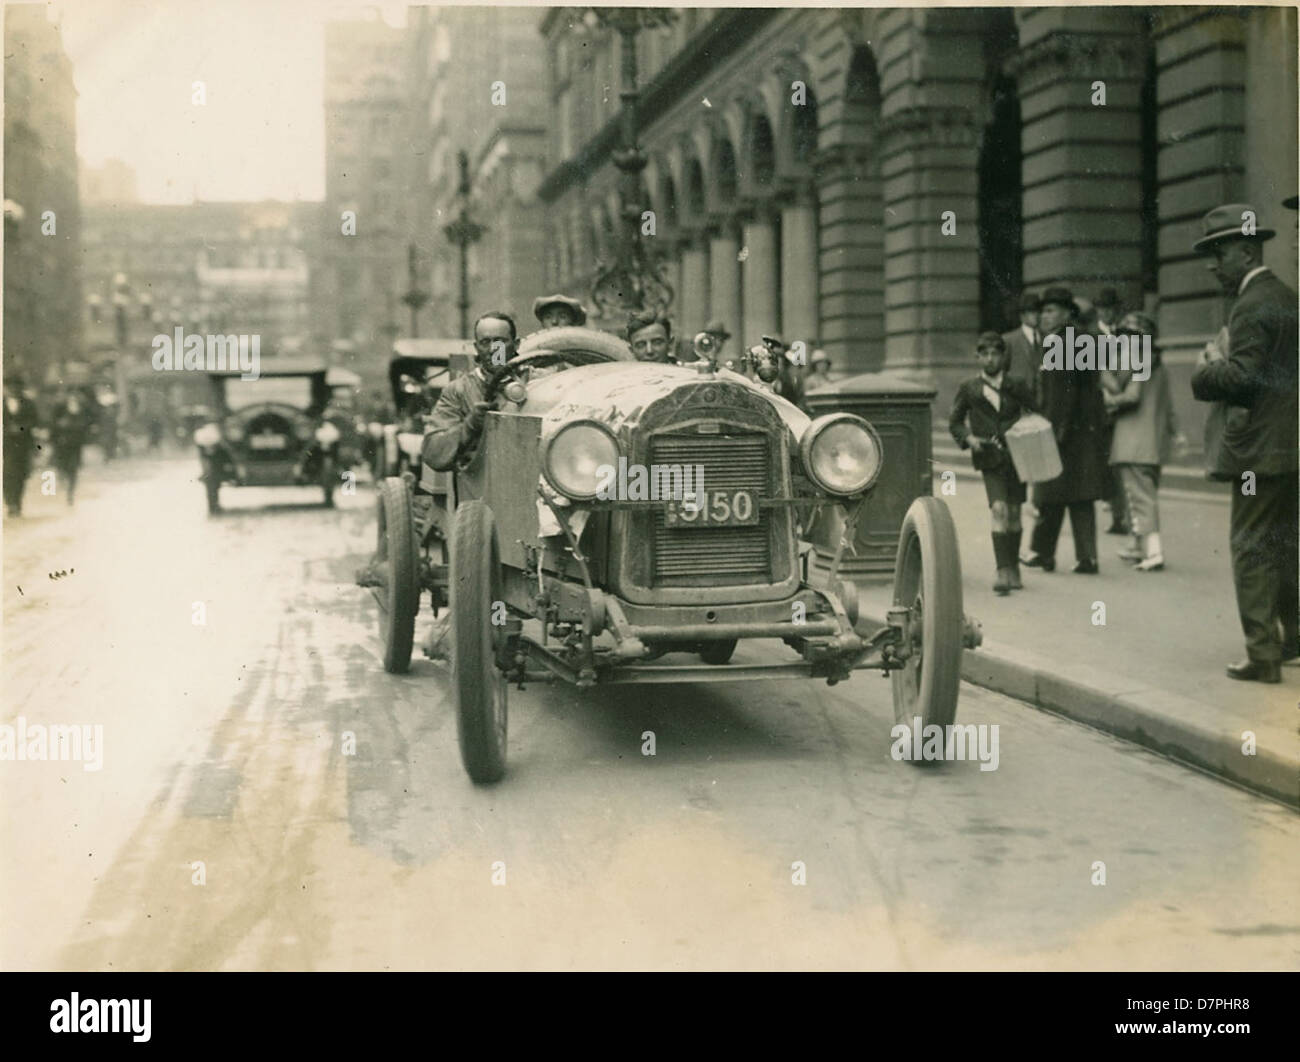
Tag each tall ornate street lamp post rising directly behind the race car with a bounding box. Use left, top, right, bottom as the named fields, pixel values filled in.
left=584, top=8, right=677, bottom=318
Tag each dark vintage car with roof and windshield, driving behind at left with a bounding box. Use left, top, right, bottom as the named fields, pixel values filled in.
left=194, top=359, right=341, bottom=515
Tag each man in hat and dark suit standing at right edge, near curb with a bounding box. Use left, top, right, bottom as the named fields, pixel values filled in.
left=1192, top=203, right=1300, bottom=682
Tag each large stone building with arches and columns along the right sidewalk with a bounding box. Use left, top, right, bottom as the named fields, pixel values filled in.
left=541, top=6, right=1296, bottom=437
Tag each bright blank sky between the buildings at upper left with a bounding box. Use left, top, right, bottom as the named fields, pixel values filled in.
left=48, top=0, right=406, bottom=203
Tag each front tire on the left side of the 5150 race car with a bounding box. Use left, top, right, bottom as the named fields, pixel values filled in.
left=449, top=500, right=507, bottom=785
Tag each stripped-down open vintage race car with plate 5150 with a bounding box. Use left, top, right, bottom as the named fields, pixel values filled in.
left=356, top=329, right=979, bottom=783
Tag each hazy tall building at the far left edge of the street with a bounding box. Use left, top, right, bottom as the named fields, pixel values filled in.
left=4, top=4, right=83, bottom=383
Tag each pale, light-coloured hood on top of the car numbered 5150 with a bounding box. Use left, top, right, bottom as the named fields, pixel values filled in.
left=519, top=361, right=810, bottom=441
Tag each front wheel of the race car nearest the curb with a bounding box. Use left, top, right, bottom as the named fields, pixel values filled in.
left=891, top=498, right=963, bottom=748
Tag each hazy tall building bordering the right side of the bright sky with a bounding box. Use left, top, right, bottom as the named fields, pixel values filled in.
left=320, top=9, right=419, bottom=368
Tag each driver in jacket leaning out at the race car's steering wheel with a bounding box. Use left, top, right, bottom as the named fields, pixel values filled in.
left=423, top=309, right=519, bottom=472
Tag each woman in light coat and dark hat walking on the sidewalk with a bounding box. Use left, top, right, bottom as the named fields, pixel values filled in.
left=1106, top=313, right=1178, bottom=572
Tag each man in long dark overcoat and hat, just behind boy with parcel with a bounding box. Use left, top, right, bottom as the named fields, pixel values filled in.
left=1022, top=287, right=1110, bottom=575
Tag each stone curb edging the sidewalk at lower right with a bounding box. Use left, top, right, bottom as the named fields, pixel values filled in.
left=863, top=615, right=1300, bottom=810
